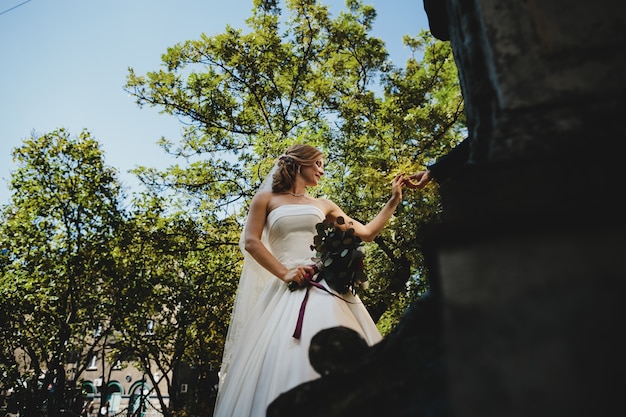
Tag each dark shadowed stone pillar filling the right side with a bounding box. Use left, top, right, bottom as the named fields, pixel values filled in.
left=430, top=0, right=626, bottom=417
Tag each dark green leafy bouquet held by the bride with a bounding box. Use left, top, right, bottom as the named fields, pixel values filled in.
left=311, top=217, right=367, bottom=294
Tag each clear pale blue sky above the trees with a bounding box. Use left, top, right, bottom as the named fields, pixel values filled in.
left=0, top=0, right=428, bottom=204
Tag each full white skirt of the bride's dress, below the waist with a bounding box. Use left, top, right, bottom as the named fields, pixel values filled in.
left=215, top=279, right=381, bottom=417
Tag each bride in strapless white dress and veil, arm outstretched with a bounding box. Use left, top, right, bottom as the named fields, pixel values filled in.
left=214, top=145, right=406, bottom=417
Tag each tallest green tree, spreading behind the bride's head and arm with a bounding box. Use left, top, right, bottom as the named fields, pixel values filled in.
left=125, top=0, right=463, bottom=334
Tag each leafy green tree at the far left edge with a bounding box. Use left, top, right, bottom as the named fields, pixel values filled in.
left=0, top=129, right=124, bottom=416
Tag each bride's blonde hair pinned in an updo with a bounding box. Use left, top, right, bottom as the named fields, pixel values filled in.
left=272, top=145, right=322, bottom=193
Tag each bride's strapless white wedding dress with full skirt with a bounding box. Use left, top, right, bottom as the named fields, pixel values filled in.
left=214, top=204, right=381, bottom=417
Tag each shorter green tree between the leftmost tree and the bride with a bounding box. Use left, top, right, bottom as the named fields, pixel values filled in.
left=108, top=193, right=240, bottom=416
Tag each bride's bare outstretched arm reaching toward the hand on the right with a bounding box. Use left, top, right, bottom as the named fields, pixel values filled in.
left=327, top=174, right=406, bottom=242
